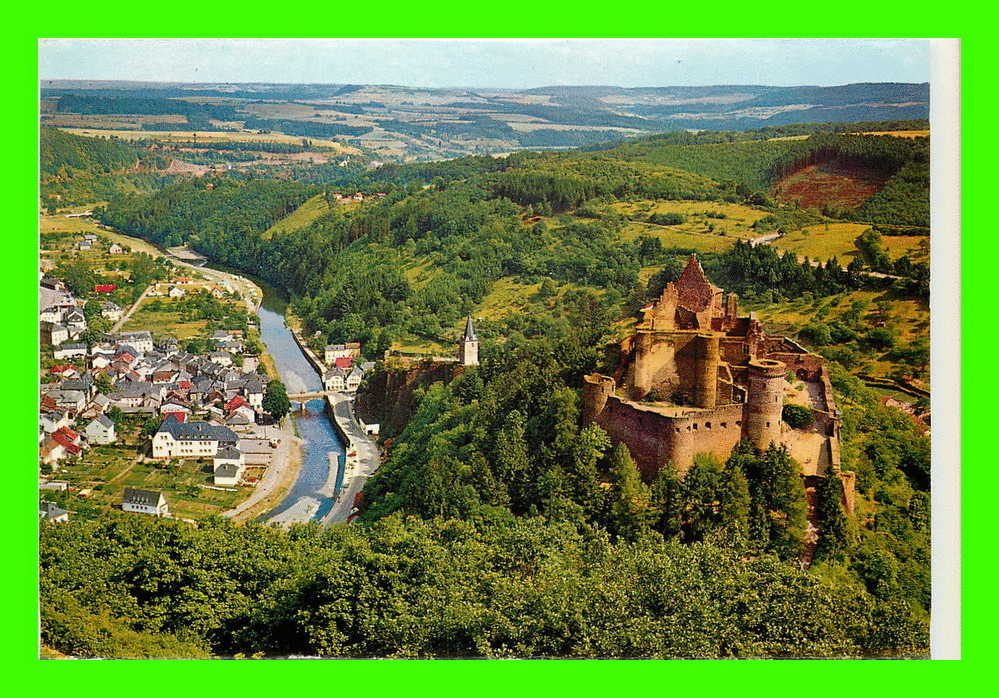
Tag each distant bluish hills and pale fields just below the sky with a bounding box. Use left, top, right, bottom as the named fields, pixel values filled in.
left=42, top=81, right=929, bottom=161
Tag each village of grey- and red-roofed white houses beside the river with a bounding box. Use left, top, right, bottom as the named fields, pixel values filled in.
left=38, top=235, right=377, bottom=521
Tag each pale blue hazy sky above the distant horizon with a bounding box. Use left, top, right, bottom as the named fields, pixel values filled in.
left=39, top=39, right=930, bottom=89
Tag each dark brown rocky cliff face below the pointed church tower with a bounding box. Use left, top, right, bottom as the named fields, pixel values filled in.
left=354, top=361, right=462, bottom=438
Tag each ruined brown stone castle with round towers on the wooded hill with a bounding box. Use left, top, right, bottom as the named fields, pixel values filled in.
left=583, top=255, right=854, bottom=510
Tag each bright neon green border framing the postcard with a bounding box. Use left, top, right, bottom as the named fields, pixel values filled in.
left=0, top=19, right=996, bottom=695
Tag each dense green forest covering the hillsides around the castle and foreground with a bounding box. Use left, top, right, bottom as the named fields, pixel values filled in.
left=41, top=126, right=930, bottom=657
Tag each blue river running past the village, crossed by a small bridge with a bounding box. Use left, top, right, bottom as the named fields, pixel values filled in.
left=257, top=284, right=345, bottom=523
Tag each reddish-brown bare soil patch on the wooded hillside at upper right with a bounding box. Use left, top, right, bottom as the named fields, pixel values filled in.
left=775, top=161, right=887, bottom=208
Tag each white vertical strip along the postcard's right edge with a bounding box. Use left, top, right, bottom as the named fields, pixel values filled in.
left=930, top=39, right=961, bottom=659
